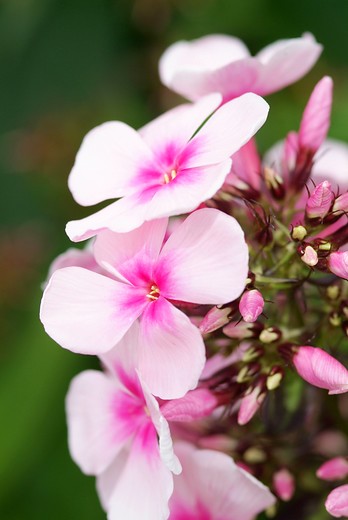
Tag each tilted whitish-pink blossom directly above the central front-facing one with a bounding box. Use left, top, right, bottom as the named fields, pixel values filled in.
left=67, top=94, right=269, bottom=241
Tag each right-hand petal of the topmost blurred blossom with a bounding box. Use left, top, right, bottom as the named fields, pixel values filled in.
left=251, top=34, right=322, bottom=95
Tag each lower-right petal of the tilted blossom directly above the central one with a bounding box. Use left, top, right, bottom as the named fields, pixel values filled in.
left=146, top=159, right=231, bottom=220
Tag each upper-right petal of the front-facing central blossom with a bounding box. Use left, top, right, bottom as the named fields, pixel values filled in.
left=156, top=209, right=248, bottom=304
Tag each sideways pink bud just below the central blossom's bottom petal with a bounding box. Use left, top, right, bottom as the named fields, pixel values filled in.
left=161, top=388, right=218, bottom=422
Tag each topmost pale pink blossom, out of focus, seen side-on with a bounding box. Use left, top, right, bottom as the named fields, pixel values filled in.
left=159, top=34, right=322, bottom=101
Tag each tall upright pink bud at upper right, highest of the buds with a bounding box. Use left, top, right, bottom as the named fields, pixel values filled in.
left=298, top=76, right=333, bottom=152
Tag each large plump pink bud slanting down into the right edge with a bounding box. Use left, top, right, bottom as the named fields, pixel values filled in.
left=293, top=346, right=348, bottom=394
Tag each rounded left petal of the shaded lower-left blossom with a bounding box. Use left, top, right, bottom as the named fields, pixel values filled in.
left=66, top=370, right=129, bottom=475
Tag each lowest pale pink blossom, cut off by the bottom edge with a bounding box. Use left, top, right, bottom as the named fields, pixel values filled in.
left=169, top=443, right=275, bottom=520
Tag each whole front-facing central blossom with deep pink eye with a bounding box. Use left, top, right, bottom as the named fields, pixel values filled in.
left=41, top=209, right=248, bottom=399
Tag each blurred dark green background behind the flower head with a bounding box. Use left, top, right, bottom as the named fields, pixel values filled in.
left=0, top=0, right=348, bottom=520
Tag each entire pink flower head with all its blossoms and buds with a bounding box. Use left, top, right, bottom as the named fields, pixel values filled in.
left=41, top=34, right=348, bottom=520
